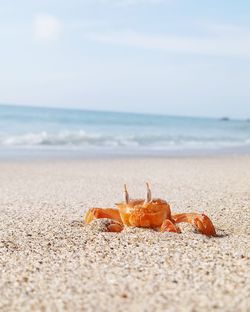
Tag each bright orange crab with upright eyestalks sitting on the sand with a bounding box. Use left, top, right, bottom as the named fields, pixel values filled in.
left=84, top=183, right=216, bottom=236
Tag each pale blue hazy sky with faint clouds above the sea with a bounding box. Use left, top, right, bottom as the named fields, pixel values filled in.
left=0, top=0, right=250, bottom=118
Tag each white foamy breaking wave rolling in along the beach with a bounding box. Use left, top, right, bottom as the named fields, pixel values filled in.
left=0, top=130, right=250, bottom=149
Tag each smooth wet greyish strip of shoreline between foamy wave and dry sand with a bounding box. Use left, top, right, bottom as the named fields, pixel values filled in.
left=0, top=146, right=250, bottom=161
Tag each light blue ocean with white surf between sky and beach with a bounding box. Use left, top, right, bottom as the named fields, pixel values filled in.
left=0, top=105, right=250, bottom=157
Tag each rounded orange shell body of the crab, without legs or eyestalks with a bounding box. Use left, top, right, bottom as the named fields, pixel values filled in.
left=116, top=199, right=171, bottom=228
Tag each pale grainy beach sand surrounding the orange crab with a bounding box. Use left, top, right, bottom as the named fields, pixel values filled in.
left=0, top=156, right=250, bottom=312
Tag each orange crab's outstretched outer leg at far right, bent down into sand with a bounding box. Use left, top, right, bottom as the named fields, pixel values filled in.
left=172, top=213, right=216, bottom=236
